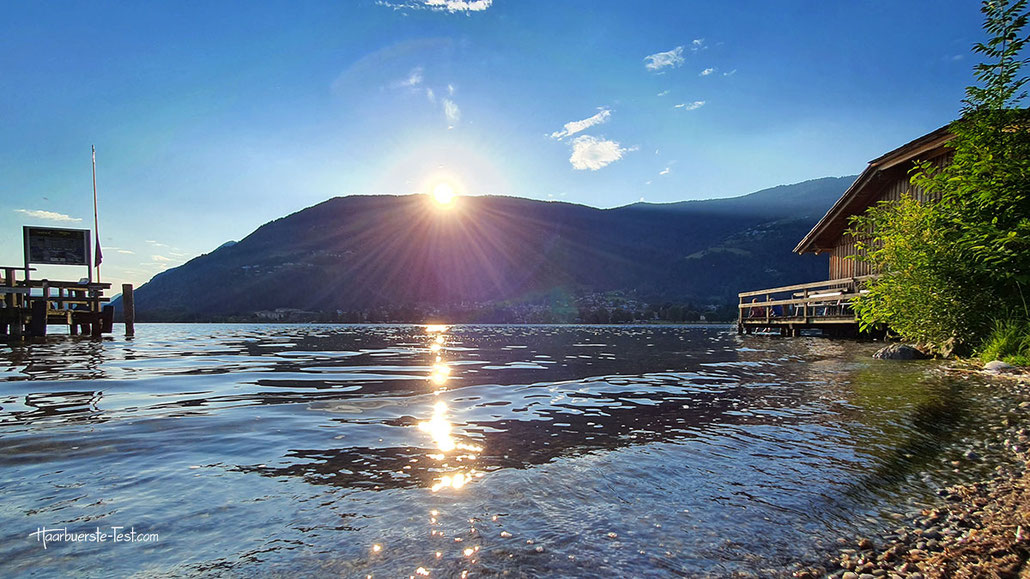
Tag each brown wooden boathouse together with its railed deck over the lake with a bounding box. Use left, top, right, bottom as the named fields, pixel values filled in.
left=737, top=127, right=954, bottom=336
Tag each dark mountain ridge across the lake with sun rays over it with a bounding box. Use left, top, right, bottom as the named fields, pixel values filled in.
left=124, top=176, right=854, bottom=320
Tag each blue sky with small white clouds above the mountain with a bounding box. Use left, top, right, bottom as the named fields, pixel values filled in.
left=0, top=0, right=983, bottom=285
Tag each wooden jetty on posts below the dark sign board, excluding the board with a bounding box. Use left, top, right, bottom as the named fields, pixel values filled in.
left=0, top=267, right=114, bottom=340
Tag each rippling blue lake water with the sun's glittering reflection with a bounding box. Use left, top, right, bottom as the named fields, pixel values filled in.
left=0, top=325, right=1013, bottom=577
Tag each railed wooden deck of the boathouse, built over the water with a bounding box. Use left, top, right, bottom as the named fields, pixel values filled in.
left=736, top=275, right=873, bottom=337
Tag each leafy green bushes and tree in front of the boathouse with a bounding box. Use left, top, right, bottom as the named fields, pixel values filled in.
left=850, top=0, right=1030, bottom=346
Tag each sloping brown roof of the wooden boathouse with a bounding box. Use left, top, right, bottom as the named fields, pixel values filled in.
left=794, top=125, right=955, bottom=253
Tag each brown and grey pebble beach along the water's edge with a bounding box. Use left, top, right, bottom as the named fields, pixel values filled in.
left=792, top=363, right=1030, bottom=579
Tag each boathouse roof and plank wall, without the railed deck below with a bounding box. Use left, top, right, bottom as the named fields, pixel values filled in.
left=794, top=127, right=955, bottom=279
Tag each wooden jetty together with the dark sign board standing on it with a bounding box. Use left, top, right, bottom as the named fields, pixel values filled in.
left=0, top=226, right=114, bottom=340
